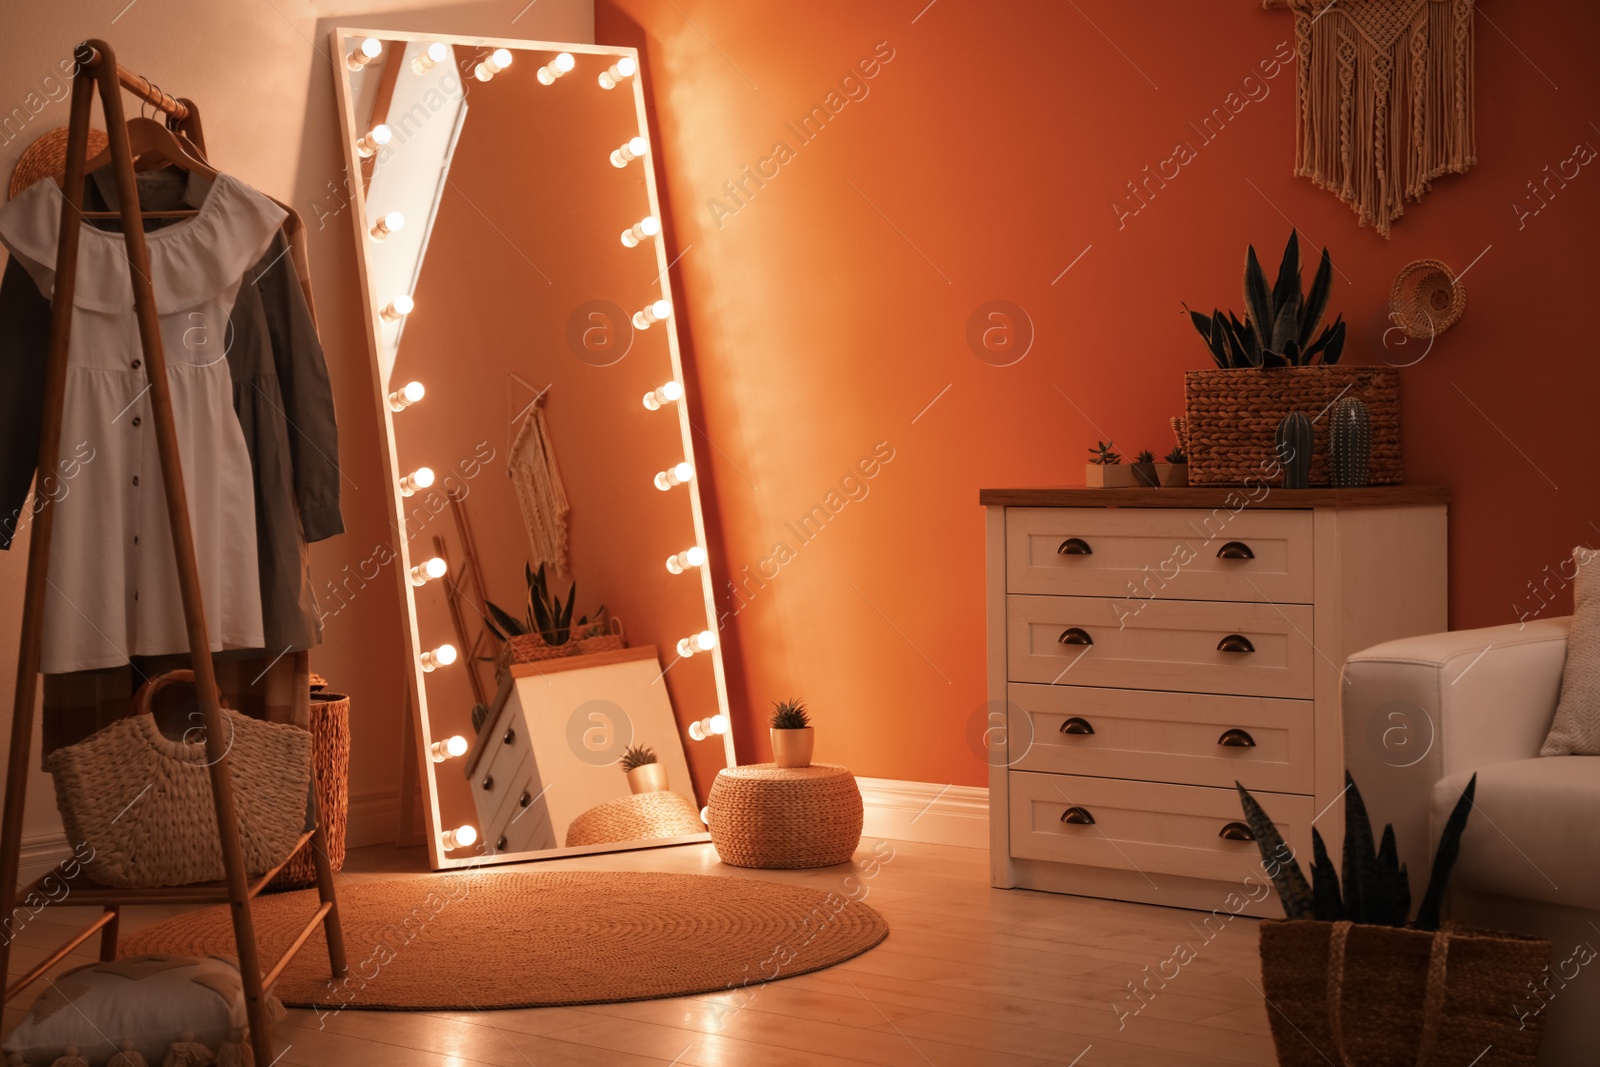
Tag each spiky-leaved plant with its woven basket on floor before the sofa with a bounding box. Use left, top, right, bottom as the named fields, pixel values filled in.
left=1235, top=773, right=1550, bottom=1067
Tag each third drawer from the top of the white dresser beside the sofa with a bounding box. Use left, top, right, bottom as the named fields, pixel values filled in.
left=1006, top=683, right=1314, bottom=793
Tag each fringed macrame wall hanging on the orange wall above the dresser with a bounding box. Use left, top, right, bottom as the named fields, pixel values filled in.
left=1262, top=0, right=1477, bottom=237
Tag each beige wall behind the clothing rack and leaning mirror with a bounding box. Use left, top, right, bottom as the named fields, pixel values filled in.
left=0, top=0, right=594, bottom=870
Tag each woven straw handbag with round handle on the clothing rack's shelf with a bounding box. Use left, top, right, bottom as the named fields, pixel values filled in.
left=45, top=670, right=312, bottom=889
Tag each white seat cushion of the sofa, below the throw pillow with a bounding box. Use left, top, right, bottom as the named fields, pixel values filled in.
left=1429, top=755, right=1600, bottom=910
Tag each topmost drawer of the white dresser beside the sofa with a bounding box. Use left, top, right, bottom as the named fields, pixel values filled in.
left=1005, top=507, right=1312, bottom=603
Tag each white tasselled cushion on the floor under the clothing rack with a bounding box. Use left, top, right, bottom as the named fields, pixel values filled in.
left=0, top=955, right=246, bottom=1067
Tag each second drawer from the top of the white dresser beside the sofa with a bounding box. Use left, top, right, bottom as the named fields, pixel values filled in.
left=1006, top=597, right=1315, bottom=699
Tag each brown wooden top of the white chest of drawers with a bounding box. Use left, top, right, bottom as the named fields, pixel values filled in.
left=978, top=485, right=1450, bottom=509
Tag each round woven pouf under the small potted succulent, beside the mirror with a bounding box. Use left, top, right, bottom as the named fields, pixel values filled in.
left=707, top=763, right=861, bottom=869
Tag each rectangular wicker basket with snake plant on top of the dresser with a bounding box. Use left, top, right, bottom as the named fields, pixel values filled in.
left=1184, top=230, right=1402, bottom=485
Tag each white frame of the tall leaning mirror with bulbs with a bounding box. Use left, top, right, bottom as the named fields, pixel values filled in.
left=331, top=27, right=738, bottom=870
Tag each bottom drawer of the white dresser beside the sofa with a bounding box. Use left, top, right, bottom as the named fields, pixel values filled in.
left=1008, top=771, right=1317, bottom=889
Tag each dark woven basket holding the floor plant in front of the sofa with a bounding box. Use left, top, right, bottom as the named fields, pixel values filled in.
left=1261, top=920, right=1550, bottom=1067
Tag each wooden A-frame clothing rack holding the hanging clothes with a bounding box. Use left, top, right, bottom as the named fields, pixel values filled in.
left=0, top=40, right=347, bottom=1067
